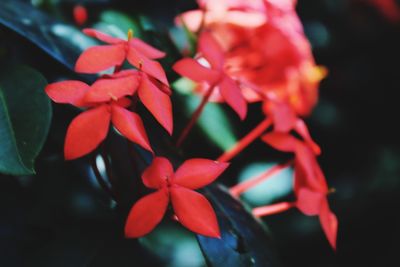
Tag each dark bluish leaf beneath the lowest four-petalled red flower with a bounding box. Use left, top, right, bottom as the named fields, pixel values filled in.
left=198, top=186, right=279, bottom=267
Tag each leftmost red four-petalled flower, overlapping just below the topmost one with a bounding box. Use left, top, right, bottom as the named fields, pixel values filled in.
left=45, top=71, right=155, bottom=160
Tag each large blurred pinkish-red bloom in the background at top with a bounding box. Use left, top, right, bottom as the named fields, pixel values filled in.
left=177, top=0, right=326, bottom=115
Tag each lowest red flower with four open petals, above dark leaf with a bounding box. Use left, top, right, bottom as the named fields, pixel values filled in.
left=125, top=157, right=229, bottom=238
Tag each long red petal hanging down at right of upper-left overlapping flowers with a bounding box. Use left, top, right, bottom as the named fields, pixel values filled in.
left=139, top=74, right=173, bottom=135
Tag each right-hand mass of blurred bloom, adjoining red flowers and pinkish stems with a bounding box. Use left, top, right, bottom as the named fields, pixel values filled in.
left=174, top=0, right=337, bottom=251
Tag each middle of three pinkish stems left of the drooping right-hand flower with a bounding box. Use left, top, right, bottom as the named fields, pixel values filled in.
left=229, top=160, right=293, bottom=197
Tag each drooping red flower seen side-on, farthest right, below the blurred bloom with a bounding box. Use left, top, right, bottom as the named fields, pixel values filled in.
left=262, top=131, right=338, bottom=249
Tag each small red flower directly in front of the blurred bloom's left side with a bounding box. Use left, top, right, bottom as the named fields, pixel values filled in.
left=173, top=32, right=247, bottom=119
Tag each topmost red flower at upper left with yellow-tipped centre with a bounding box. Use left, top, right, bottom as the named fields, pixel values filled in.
left=75, top=29, right=168, bottom=85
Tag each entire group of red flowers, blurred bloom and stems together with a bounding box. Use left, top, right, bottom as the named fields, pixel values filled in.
left=45, top=0, right=338, bottom=253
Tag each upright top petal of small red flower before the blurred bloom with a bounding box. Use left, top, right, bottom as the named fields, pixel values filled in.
left=198, top=32, right=224, bottom=69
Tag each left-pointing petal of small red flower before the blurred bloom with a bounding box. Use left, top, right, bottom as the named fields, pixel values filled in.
left=172, top=58, right=221, bottom=84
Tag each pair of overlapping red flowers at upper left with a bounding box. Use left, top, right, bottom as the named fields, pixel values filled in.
left=45, top=29, right=173, bottom=160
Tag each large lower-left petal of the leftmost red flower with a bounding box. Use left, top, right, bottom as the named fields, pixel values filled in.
left=64, top=105, right=111, bottom=160
